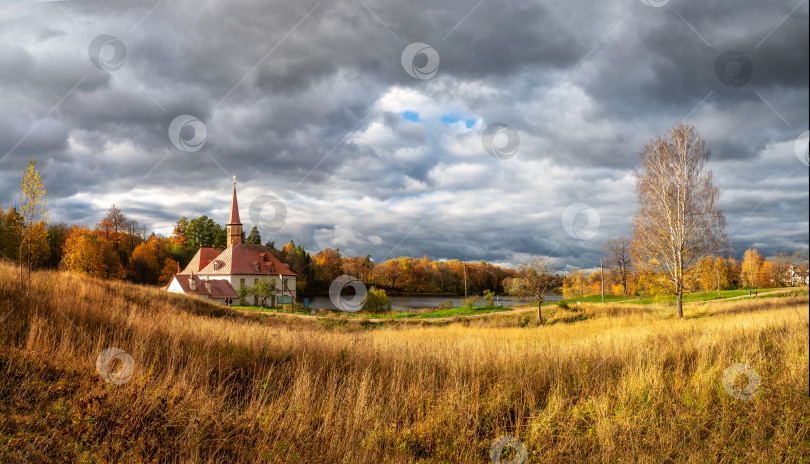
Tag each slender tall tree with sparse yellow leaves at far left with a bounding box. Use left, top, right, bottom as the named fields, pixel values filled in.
left=20, top=158, right=50, bottom=290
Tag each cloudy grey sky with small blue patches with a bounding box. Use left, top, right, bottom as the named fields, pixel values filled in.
left=0, top=0, right=810, bottom=268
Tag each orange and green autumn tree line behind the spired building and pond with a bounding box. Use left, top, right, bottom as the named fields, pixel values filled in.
left=0, top=160, right=514, bottom=296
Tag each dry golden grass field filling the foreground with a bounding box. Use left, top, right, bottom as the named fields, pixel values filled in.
left=0, top=263, right=810, bottom=463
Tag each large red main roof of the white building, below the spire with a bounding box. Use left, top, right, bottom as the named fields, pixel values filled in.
left=199, top=243, right=295, bottom=276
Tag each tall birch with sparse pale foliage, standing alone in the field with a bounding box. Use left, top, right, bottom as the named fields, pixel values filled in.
left=633, top=123, right=727, bottom=318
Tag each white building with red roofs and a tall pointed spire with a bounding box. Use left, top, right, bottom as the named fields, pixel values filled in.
left=166, top=177, right=296, bottom=305
